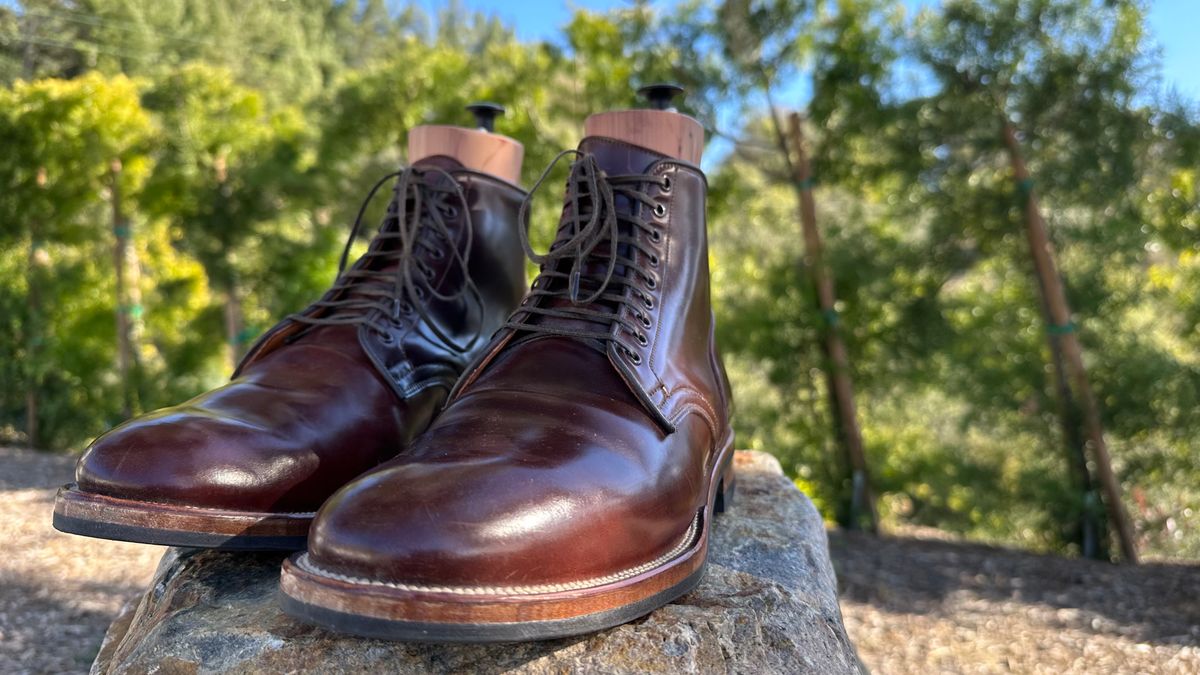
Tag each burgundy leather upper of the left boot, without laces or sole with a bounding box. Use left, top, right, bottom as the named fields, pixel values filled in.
left=76, top=157, right=526, bottom=513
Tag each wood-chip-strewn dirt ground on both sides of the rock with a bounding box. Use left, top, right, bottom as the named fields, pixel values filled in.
left=0, top=448, right=1200, bottom=674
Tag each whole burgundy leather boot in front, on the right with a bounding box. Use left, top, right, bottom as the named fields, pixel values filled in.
left=282, top=138, right=733, bottom=641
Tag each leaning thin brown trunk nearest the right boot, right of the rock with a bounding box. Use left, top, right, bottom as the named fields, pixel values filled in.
left=785, top=113, right=878, bottom=532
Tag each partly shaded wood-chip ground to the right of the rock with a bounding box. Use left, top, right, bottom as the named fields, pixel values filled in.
left=829, top=531, right=1200, bottom=674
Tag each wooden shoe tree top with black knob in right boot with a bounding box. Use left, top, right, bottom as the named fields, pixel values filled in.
left=583, top=83, right=704, bottom=165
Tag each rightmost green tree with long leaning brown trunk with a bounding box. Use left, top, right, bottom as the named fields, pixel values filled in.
left=916, top=0, right=1145, bottom=561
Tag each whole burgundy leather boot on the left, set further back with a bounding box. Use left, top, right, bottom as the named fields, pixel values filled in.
left=54, top=156, right=526, bottom=550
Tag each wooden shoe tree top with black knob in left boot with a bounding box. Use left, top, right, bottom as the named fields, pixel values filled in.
left=408, top=101, right=524, bottom=184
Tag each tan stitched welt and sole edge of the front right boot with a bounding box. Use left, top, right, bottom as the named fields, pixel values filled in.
left=280, top=437, right=733, bottom=643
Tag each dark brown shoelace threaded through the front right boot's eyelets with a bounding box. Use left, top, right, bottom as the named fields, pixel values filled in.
left=506, top=150, right=670, bottom=365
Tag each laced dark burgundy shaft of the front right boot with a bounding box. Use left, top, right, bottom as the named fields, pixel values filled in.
left=451, top=137, right=731, bottom=432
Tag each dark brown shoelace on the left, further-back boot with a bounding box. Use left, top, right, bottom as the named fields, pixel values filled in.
left=288, top=167, right=484, bottom=353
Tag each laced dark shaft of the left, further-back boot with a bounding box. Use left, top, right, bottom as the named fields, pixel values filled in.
left=234, top=156, right=526, bottom=398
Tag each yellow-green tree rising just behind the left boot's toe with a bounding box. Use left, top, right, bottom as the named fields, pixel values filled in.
left=142, top=64, right=311, bottom=369
